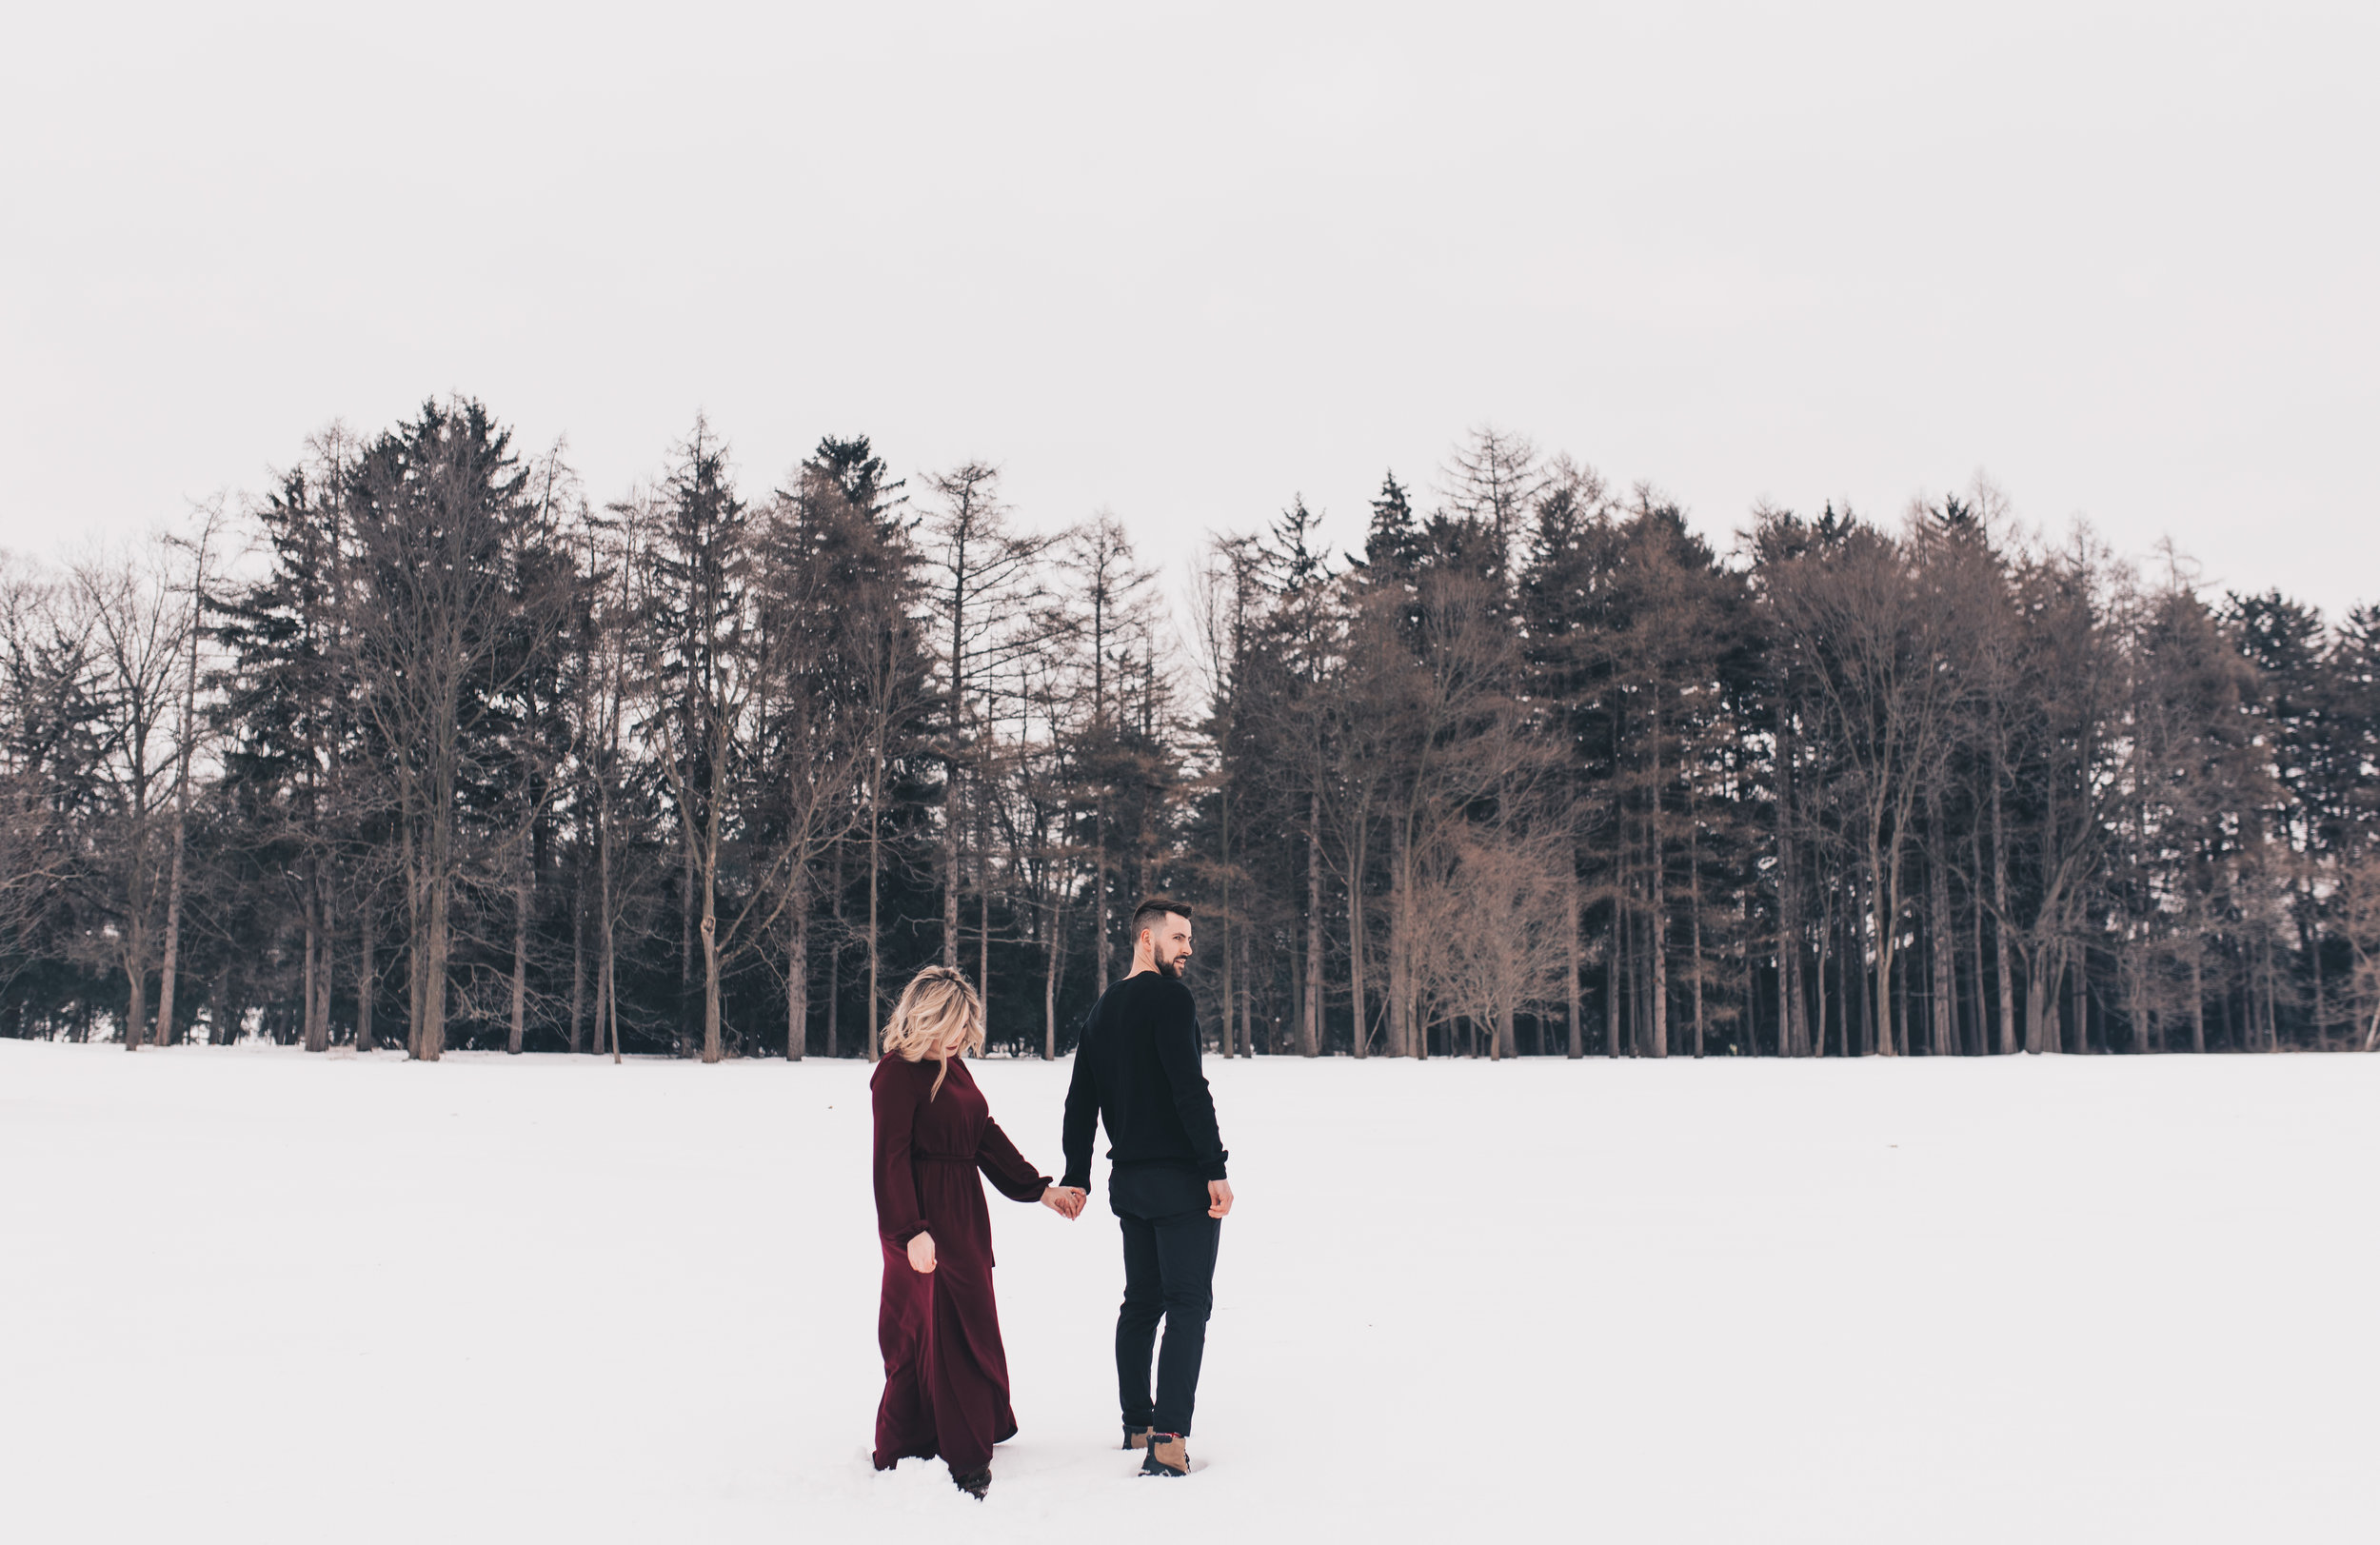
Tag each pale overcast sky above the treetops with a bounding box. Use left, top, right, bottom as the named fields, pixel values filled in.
left=0, top=0, right=2380, bottom=612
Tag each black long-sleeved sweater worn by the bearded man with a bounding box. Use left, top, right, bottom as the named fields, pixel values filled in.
left=1061, top=971, right=1228, bottom=1190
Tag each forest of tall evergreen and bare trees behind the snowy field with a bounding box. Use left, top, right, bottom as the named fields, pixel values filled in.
left=0, top=400, right=2380, bottom=1061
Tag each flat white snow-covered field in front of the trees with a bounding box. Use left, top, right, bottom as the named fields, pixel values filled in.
left=0, top=1040, right=2380, bottom=1545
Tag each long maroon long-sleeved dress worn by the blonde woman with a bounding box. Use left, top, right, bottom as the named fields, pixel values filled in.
left=869, top=1057, right=1050, bottom=1471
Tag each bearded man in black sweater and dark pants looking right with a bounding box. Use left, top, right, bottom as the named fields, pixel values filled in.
left=1061, top=895, right=1231, bottom=1476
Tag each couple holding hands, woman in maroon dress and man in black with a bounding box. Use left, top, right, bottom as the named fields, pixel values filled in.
left=869, top=895, right=1231, bottom=1497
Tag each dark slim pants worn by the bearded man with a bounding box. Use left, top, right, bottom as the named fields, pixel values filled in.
left=1107, top=1164, right=1223, bottom=1433
